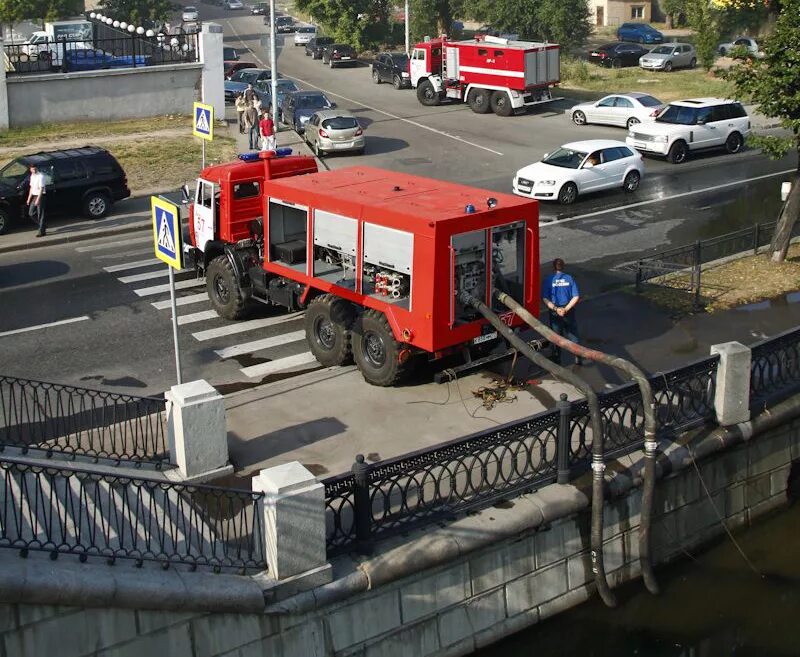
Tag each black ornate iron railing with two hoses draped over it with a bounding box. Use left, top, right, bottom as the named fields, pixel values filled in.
left=323, top=356, right=718, bottom=554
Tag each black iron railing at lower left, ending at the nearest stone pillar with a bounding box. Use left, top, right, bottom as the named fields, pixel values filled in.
left=0, top=461, right=266, bottom=573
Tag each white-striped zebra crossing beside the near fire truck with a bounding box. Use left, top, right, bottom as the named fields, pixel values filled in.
left=80, top=236, right=319, bottom=379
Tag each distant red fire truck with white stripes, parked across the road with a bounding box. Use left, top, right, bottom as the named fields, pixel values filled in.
left=409, top=34, right=561, bottom=116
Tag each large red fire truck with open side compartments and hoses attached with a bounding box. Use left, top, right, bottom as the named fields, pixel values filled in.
left=188, top=153, right=539, bottom=386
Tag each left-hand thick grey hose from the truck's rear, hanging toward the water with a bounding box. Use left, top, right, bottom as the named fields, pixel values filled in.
left=459, top=292, right=617, bottom=607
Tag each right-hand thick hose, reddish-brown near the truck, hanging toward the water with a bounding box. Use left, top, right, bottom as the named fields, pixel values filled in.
left=493, top=289, right=660, bottom=595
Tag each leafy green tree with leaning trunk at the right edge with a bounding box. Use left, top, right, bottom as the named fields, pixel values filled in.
left=727, top=0, right=800, bottom=262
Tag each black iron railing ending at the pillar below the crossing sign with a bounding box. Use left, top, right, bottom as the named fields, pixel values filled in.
left=0, top=376, right=168, bottom=467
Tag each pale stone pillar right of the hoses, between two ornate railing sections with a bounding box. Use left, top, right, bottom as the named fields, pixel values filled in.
left=711, top=342, right=751, bottom=427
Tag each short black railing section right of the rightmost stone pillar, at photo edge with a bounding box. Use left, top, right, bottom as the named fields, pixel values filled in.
left=750, top=328, right=800, bottom=410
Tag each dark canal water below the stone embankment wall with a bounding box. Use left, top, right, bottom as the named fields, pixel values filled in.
left=474, top=503, right=800, bottom=657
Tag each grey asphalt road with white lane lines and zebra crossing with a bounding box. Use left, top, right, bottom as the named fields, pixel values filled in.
left=0, top=5, right=794, bottom=393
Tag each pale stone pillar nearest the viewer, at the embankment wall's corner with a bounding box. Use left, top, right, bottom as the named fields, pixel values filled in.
left=252, top=461, right=327, bottom=580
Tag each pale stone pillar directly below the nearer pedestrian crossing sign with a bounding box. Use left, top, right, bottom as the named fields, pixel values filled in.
left=165, top=379, right=230, bottom=481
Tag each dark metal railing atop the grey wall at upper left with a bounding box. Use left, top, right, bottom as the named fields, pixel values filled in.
left=3, top=34, right=199, bottom=75
